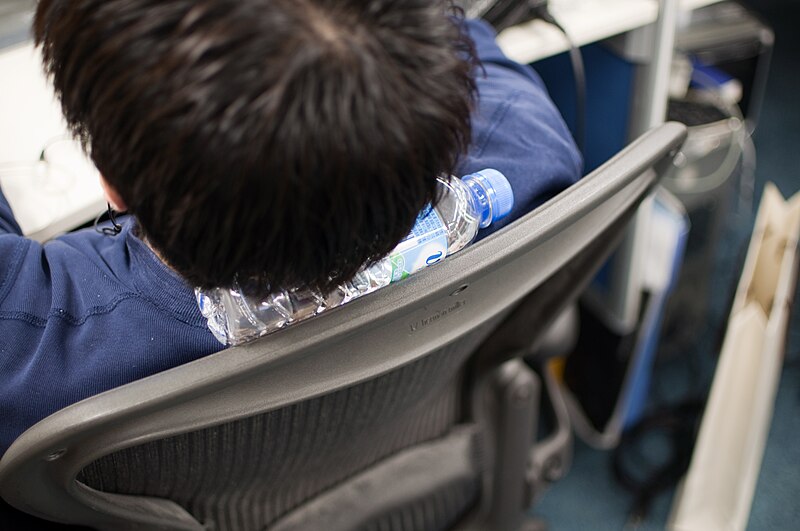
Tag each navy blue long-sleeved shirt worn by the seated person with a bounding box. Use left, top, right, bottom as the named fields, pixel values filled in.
left=0, top=21, right=581, bottom=454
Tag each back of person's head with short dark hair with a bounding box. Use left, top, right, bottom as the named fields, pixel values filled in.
left=35, top=0, right=474, bottom=296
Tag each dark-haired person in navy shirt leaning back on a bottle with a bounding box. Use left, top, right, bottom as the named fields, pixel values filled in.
left=0, top=0, right=581, bottom=453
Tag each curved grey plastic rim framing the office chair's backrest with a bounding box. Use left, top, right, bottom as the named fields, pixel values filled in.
left=0, top=123, right=685, bottom=529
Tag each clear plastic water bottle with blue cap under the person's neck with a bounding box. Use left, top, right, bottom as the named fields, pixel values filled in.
left=195, top=169, right=514, bottom=345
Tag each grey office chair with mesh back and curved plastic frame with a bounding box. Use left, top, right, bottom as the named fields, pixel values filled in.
left=0, top=123, right=685, bottom=531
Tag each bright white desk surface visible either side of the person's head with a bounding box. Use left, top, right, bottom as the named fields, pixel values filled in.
left=0, top=0, right=718, bottom=241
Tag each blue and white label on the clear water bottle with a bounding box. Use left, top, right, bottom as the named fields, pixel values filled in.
left=389, top=207, right=447, bottom=282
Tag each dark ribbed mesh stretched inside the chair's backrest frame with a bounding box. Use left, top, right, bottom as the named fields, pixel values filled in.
left=79, top=323, right=491, bottom=531
